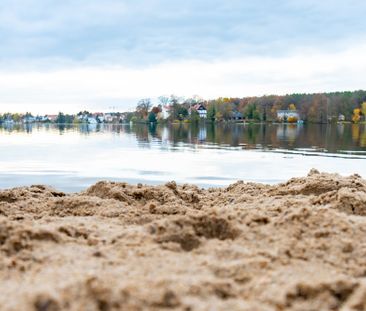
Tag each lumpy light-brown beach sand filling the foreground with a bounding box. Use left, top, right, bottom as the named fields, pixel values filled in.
left=0, top=170, right=366, bottom=311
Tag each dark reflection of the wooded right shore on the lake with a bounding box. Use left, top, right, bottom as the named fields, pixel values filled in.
left=129, top=124, right=366, bottom=153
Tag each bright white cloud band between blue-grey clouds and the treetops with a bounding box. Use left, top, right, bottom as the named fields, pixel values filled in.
left=0, top=45, right=366, bottom=113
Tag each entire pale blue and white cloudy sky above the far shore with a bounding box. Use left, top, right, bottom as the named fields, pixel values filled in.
left=0, top=0, right=366, bottom=113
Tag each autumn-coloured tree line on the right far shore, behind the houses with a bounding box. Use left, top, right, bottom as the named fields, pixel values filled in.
left=126, top=90, right=366, bottom=123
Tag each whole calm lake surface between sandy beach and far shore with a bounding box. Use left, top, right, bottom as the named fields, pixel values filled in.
left=0, top=124, right=366, bottom=191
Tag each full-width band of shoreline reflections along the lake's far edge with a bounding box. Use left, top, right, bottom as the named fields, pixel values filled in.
left=0, top=123, right=366, bottom=154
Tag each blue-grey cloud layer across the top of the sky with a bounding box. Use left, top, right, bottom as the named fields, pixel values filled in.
left=0, top=0, right=366, bottom=66
